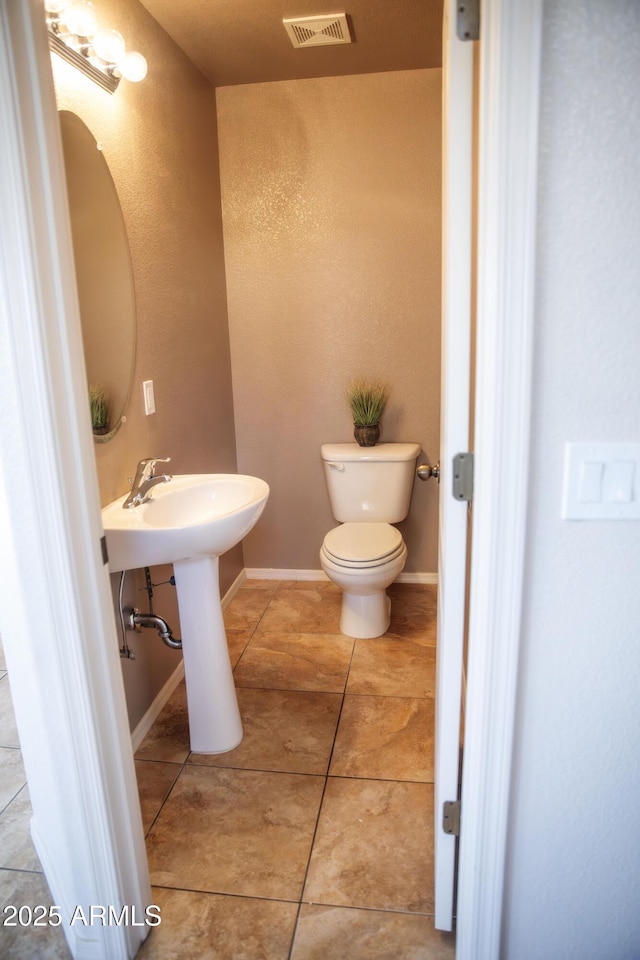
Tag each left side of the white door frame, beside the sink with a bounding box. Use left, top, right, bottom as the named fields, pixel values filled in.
left=0, top=0, right=151, bottom=960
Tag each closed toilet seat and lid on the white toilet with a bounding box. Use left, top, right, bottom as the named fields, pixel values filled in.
left=322, top=522, right=405, bottom=570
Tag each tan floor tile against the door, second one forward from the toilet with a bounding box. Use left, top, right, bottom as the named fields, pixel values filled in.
left=329, top=696, right=434, bottom=783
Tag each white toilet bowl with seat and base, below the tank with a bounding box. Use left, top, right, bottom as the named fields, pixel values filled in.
left=320, top=522, right=407, bottom=640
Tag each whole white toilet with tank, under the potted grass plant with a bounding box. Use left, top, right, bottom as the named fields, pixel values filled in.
left=320, top=443, right=420, bottom=640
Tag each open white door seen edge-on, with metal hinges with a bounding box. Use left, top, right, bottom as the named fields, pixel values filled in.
left=434, top=0, right=474, bottom=930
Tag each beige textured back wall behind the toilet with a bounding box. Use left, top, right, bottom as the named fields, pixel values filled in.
left=216, top=69, right=441, bottom=573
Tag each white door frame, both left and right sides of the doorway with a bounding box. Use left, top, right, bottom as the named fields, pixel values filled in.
left=0, top=0, right=542, bottom=960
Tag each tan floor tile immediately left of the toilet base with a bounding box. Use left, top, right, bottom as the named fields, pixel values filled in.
left=260, top=586, right=342, bottom=634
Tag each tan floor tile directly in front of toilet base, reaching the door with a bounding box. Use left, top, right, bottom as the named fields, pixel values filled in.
left=347, top=637, right=436, bottom=697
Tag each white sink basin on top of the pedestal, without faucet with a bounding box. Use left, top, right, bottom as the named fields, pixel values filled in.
left=102, top=473, right=269, bottom=573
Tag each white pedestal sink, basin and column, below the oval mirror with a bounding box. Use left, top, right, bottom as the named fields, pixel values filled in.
left=102, top=473, right=269, bottom=753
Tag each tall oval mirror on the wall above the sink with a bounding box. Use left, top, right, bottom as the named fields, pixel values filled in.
left=60, top=110, right=136, bottom=443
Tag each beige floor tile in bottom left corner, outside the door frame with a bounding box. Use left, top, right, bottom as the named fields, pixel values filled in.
left=0, top=870, right=71, bottom=960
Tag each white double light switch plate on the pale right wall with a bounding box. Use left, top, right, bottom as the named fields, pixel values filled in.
left=562, top=443, right=640, bottom=520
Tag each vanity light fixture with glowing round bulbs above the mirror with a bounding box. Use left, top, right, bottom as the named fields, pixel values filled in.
left=44, top=0, right=147, bottom=93
